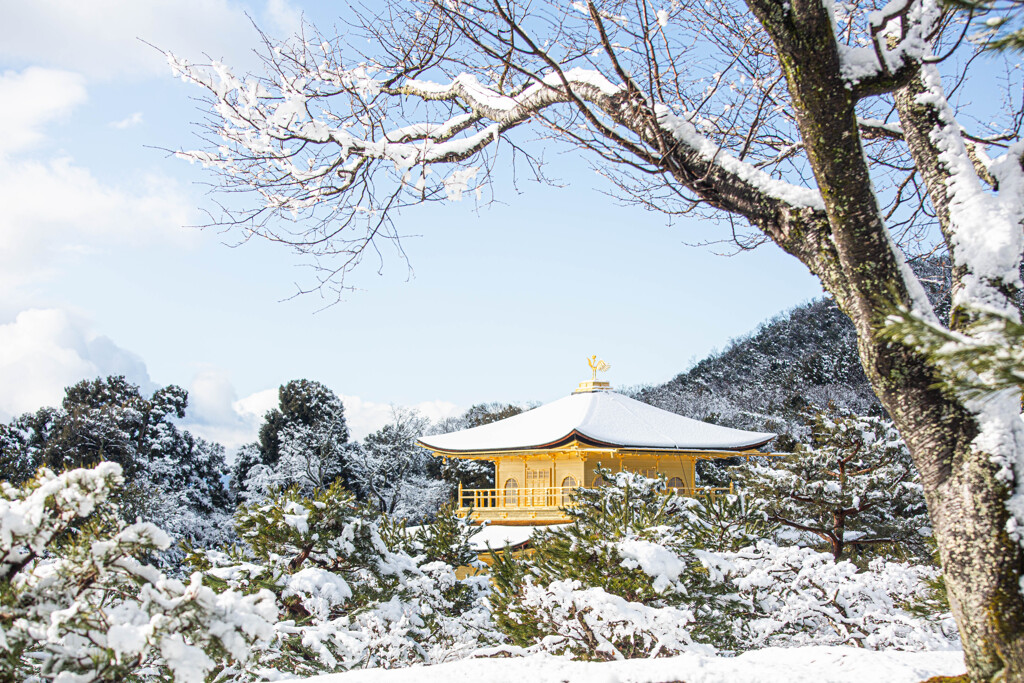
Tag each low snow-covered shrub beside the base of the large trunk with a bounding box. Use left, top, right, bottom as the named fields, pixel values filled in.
left=703, top=541, right=959, bottom=650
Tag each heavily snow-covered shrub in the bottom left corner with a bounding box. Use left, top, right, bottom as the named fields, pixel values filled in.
left=0, top=462, right=273, bottom=682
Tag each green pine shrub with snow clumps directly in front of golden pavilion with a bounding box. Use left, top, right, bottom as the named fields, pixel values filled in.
left=492, top=470, right=765, bottom=659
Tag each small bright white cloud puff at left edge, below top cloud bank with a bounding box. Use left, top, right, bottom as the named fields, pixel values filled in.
left=0, top=67, right=86, bottom=156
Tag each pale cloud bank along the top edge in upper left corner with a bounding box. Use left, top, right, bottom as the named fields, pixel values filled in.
left=0, top=0, right=298, bottom=79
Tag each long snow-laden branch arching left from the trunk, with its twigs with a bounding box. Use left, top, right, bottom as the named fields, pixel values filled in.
left=167, top=32, right=823, bottom=285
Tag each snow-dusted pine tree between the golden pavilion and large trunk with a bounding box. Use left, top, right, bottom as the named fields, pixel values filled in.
left=735, top=408, right=931, bottom=561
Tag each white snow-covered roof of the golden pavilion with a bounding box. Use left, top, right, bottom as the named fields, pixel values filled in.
left=420, top=391, right=775, bottom=453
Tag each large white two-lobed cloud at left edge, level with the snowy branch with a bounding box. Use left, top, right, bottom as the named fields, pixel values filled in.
left=0, top=68, right=199, bottom=292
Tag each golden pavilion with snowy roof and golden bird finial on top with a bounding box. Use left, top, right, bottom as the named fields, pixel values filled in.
left=418, top=356, right=775, bottom=525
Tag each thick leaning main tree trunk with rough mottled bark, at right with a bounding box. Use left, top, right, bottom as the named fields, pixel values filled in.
left=750, top=0, right=1024, bottom=682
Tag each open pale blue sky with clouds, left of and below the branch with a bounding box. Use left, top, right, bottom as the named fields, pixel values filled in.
left=0, top=0, right=820, bottom=446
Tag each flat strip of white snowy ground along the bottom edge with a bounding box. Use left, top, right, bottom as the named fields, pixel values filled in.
left=306, top=647, right=966, bottom=683
